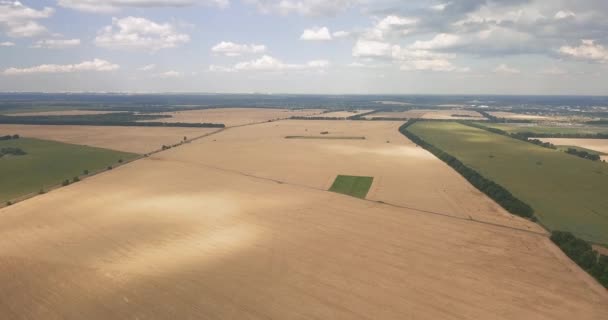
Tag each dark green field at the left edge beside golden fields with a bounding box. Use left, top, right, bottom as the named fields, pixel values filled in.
left=0, top=138, right=138, bottom=205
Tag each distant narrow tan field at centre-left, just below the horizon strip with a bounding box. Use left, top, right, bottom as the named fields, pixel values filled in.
left=142, top=108, right=324, bottom=127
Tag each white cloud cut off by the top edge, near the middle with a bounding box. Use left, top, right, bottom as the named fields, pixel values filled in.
left=245, top=0, right=360, bottom=16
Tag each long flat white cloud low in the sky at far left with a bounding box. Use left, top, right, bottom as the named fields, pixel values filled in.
left=4, top=59, right=120, bottom=75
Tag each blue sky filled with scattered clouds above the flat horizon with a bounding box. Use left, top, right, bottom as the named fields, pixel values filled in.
left=0, top=0, right=608, bottom=95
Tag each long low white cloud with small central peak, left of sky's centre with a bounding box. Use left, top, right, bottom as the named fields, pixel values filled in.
left=209, top=55, right=330, bottom=72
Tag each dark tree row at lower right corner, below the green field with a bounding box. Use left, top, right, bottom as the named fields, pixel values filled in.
left=551, top=231, right=608, bottom=288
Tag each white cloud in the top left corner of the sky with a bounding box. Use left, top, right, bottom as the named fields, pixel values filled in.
left=0, top=0, right=54, bottom=38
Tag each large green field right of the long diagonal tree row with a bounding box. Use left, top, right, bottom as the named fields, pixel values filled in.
left=408, top=122, right=608, bottom=244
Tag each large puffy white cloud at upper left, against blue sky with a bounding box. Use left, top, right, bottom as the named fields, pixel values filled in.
left=95, top=17, right=190, bottom=51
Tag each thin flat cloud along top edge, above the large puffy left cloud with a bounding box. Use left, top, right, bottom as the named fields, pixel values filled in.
left=59, top=0, right=230, bottom=13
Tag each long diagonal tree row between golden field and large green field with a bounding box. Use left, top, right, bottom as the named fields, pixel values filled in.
left=399, top=120, right=536, bottom=221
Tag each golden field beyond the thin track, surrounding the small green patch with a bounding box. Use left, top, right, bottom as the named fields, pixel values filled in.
left=154, top=120, right=542, bottom=231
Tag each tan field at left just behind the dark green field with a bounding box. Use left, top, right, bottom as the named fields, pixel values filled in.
left=0, top=124, right=217, bottom=154
